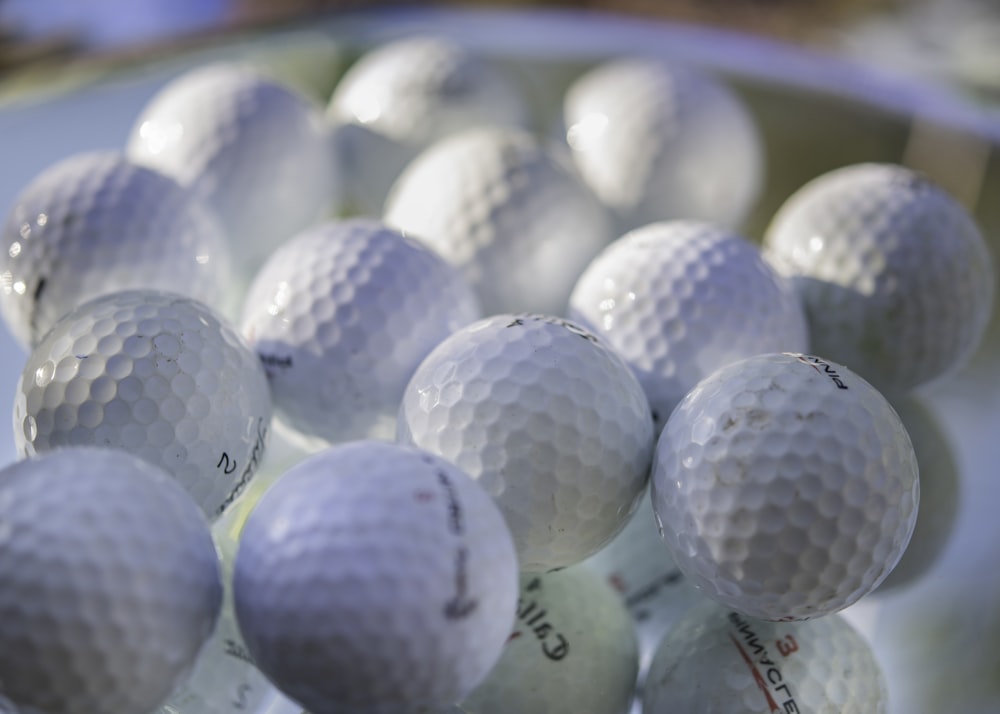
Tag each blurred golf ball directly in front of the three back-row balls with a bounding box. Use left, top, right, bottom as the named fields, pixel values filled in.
left=384, top=128, right=612, bottom=315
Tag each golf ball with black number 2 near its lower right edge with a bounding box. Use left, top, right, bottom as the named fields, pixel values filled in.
left=14, top=290, right=271, bottom=518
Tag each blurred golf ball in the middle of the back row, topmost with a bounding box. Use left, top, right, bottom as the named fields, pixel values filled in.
left=327, top=36, right=529, bottom=216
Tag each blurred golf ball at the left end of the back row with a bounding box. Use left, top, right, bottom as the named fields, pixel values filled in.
left=127, top=64, right=338, bottom=281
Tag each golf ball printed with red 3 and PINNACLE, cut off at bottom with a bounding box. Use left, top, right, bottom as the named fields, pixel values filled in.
left=642, top=604, right=888, bottom=714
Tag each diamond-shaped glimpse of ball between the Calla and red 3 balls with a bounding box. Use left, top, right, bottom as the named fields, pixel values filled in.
left=581, top=494, right=705, bottom=686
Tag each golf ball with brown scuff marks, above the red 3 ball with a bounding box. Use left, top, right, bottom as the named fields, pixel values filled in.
left=652, top=354, right=920, bottom=620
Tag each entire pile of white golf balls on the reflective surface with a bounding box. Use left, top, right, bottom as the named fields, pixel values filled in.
left=0, top=20, right=995, bottom=714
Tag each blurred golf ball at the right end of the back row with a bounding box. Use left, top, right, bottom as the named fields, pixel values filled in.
left=563, top=59, right=764, bottom=230
